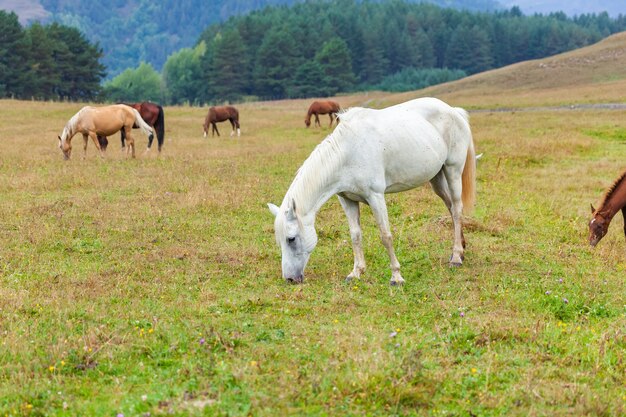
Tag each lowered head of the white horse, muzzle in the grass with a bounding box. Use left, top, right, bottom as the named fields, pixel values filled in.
left=267, top=200, right=317, bottom=284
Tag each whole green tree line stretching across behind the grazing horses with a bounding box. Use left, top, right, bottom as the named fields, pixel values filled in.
left=0, top=0, right=626, bottom=104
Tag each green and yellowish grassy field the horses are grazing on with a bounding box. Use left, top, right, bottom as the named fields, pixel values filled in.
left=0, top=42, right=626, bottom=416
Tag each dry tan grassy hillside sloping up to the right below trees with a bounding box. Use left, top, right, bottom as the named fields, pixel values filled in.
left=394, top=32, right=626, bottom=108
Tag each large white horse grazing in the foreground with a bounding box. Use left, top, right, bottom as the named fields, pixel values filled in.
left=268, top=98, right=476, bottom=285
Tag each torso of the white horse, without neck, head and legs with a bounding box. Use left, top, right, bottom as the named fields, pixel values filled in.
left=333, top=98, right=471, bottom=193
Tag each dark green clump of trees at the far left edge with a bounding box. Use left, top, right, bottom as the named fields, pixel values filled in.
left=0, top=10, right=105, bottom=101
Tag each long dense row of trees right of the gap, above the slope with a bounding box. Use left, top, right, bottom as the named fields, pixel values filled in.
left=105, top=0, right=626, bottom=104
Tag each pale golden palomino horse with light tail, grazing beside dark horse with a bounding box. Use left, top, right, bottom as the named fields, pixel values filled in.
left=59, top=104, right=153, bottom=159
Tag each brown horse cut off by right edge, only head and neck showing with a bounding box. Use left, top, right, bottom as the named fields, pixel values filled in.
left=589, top=171, right=626, bottom=246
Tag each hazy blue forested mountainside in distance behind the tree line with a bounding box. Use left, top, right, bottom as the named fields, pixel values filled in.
left=33, top=0, right=501, bottom=77
